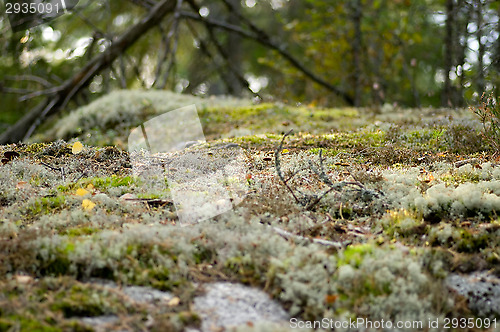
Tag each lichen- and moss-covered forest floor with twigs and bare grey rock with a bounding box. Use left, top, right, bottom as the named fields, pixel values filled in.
left=0, top=92, right=500, bottom=331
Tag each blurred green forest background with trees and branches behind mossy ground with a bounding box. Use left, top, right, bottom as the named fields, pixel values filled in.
left=0, top=0, right=500, bottom=143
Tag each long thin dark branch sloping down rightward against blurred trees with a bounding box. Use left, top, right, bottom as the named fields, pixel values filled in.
left=180, top=11, right=354, bottom=105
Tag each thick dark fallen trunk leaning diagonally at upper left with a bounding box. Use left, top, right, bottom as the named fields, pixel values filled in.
left=0, top=0, right=176, bottom=144
